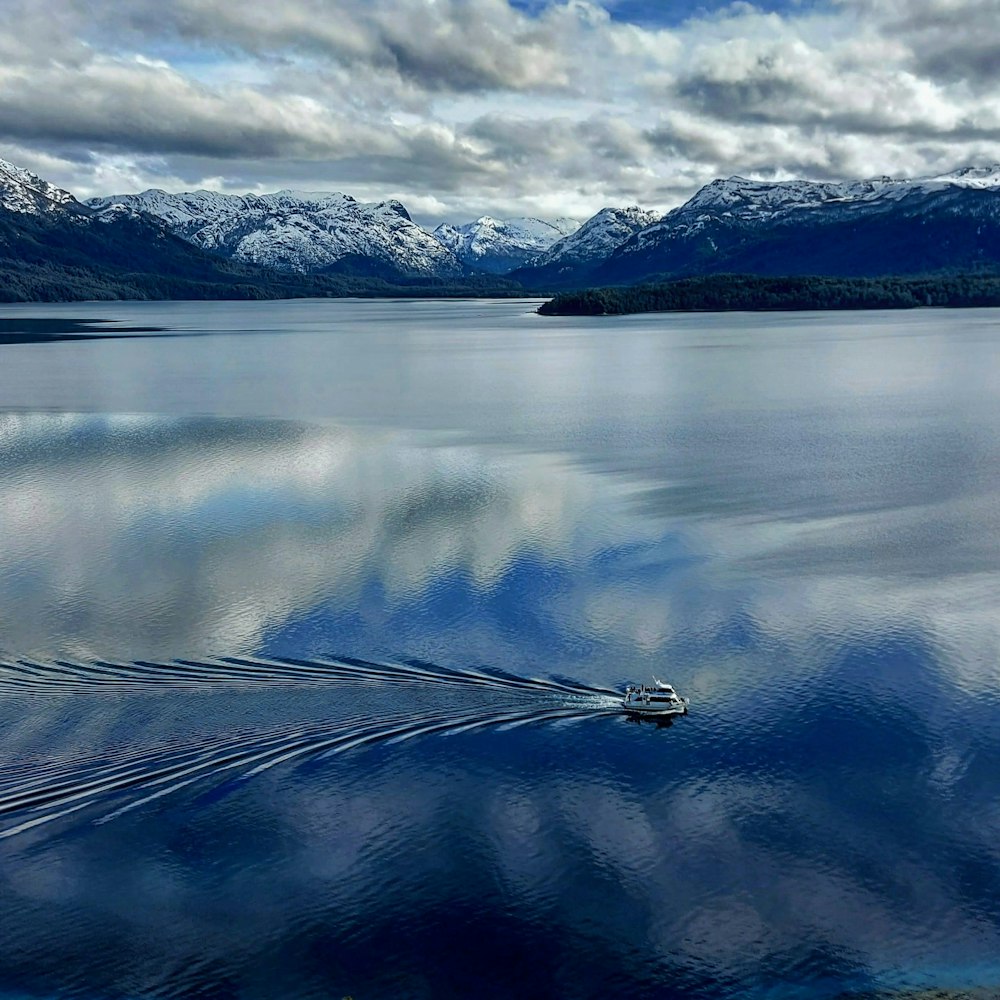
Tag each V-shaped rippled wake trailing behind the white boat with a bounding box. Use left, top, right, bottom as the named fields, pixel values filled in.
left=0, top=657, right=621, bottom=840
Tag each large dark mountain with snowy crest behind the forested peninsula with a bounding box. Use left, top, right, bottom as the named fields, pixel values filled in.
left=584, top=165, right=1000, bottom=287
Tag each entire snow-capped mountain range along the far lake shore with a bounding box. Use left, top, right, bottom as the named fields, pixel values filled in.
left=0, top=153, right=1000, bottom=298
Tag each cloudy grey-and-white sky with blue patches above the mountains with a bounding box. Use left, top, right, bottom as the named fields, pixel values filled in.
left=0, top=0, right=1000, bottom=225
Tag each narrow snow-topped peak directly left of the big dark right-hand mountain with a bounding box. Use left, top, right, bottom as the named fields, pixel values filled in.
left=510, top=205, right=660, bottom=287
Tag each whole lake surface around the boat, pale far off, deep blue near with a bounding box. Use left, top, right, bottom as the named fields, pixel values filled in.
left=0, top=302, right=1000, bottom=1000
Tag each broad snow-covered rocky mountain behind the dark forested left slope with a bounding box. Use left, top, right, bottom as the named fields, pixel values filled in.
left=87, top=190, right=465, bottom=278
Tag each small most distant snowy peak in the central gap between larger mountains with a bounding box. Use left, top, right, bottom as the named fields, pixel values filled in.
left=431, top=215, right=580, bottom=274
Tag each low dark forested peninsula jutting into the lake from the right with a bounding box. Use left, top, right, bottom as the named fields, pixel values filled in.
left=538, top=274, right=1000, bottom=316
